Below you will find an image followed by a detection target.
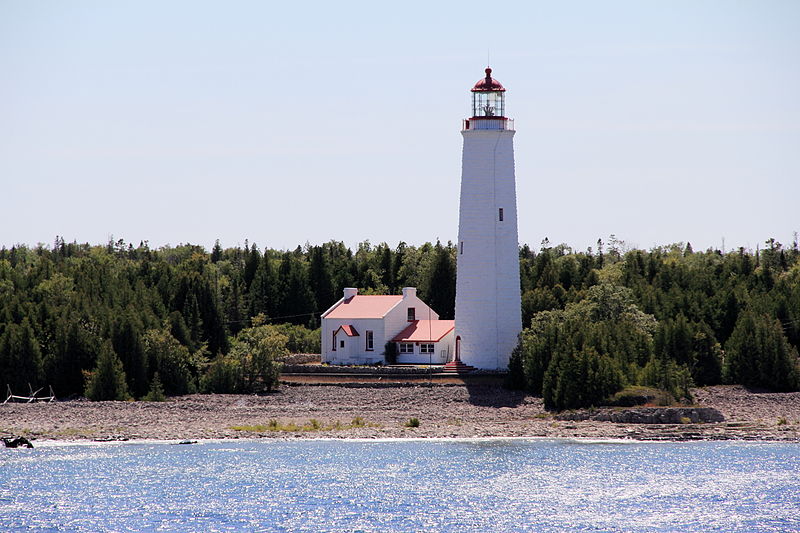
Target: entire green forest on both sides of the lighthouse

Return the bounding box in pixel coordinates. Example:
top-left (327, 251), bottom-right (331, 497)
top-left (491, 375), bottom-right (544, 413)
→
top-left (0, 236), bottom-right (800, 409)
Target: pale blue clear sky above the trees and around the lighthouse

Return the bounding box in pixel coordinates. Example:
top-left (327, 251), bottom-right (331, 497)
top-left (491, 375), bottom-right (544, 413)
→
top-left (0, 0), bottom-right (800, 254)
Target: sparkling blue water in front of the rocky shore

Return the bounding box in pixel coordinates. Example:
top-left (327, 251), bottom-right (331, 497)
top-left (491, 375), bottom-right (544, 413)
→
top-left (0, 440), bottom-right (800, 532)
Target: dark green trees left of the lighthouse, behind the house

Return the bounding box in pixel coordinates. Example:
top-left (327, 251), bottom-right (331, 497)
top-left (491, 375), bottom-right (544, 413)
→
top-left (0, 237), bottom-right (455, 399)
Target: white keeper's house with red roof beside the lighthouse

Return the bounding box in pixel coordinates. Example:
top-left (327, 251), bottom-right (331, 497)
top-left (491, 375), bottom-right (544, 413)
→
top-left (322, 287), bottom-right (455, 365)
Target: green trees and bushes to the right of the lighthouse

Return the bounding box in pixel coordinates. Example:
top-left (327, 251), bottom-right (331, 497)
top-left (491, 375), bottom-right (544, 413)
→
top-left (510, 236), bottom-right (800, 409)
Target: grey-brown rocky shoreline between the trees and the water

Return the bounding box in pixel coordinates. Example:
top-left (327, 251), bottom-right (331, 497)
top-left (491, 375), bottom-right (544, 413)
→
top-left (0, 383), bottom-right (800, 442)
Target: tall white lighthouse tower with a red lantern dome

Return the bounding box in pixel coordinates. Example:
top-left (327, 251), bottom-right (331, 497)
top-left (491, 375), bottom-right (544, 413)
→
top-left (455, 68), bottom-right (522, 370)
